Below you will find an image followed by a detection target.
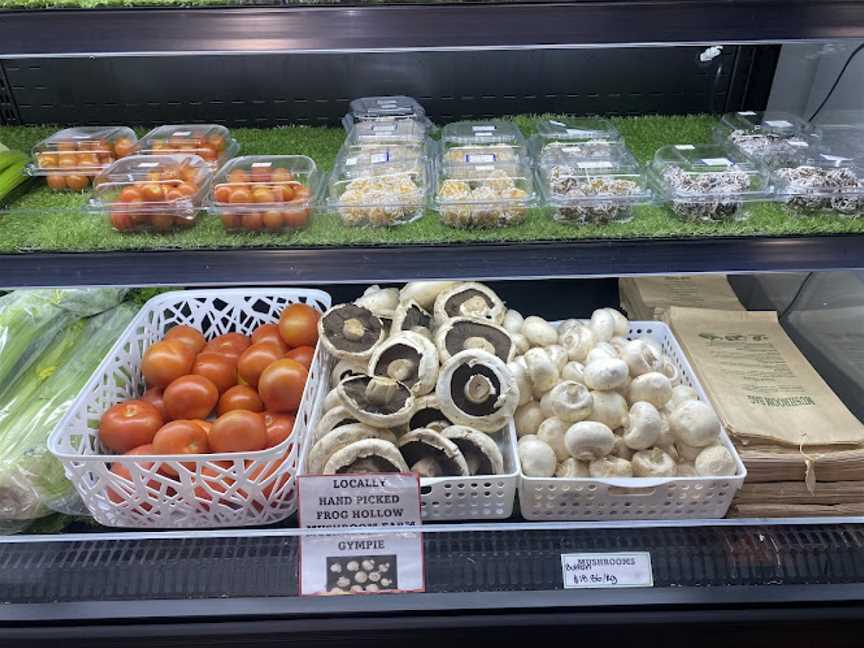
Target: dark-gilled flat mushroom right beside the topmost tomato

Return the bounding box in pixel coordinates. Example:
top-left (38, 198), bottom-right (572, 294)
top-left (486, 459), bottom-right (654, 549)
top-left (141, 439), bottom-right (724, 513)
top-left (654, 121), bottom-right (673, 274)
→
top-left (318, 304), bottom-right (385, 362)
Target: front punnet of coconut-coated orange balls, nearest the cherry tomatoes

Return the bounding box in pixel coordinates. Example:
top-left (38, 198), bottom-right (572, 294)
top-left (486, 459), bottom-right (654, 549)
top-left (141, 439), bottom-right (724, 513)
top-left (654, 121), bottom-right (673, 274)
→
top-left (327, 146), bottom-right (429, 227)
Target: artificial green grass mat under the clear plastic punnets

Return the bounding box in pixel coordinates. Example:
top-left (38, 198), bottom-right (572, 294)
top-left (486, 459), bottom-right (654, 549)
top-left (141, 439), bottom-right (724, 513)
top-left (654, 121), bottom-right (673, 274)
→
top-left (0, 115), bottom-right (864, 253)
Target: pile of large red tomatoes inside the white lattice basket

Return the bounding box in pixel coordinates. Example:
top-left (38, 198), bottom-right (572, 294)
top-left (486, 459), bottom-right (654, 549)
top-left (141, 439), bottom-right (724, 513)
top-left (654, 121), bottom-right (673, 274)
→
top-left (99, 303), bottom-right (320, 496)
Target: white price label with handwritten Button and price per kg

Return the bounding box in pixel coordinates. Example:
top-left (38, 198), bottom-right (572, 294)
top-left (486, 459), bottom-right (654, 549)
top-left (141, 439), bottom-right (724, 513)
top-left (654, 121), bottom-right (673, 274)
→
top-left (561, 551), bottom-right (654, 589)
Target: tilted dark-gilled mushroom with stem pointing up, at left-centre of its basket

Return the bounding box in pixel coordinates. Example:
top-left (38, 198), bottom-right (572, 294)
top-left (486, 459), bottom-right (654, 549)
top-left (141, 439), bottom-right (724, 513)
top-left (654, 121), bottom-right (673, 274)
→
top-left (339, 376), bottom-right (414, 427)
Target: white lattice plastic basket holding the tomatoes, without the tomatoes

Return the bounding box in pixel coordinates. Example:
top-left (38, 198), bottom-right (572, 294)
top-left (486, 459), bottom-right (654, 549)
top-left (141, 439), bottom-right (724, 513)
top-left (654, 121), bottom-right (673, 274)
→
top-left (48, 288), bottom-right (330, 529)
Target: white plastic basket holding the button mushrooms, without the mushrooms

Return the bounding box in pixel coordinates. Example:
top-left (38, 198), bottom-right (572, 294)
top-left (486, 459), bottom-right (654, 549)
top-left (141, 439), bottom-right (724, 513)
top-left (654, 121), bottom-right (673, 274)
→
top-left (519, 322), bottom-right (747, 520)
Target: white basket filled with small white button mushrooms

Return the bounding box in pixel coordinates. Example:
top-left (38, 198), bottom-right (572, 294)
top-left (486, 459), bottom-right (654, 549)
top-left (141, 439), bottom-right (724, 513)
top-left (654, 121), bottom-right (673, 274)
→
top-left (503, 308), bottom-right (747, 520)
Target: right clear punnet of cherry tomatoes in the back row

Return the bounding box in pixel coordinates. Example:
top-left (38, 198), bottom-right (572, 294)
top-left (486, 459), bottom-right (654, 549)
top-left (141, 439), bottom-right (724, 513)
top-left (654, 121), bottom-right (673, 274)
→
top-left (136, 124), bottom-right (240, 171)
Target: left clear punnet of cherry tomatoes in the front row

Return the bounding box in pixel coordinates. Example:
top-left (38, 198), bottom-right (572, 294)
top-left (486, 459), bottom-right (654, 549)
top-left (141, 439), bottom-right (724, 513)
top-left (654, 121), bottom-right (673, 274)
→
top-left (90, 155), bottom-right (212, 232)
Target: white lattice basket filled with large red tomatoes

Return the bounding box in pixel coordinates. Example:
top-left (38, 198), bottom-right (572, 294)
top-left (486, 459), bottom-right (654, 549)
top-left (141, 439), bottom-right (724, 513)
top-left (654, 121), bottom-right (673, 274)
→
top-left (48, 289), bottom-right (330, 529)
